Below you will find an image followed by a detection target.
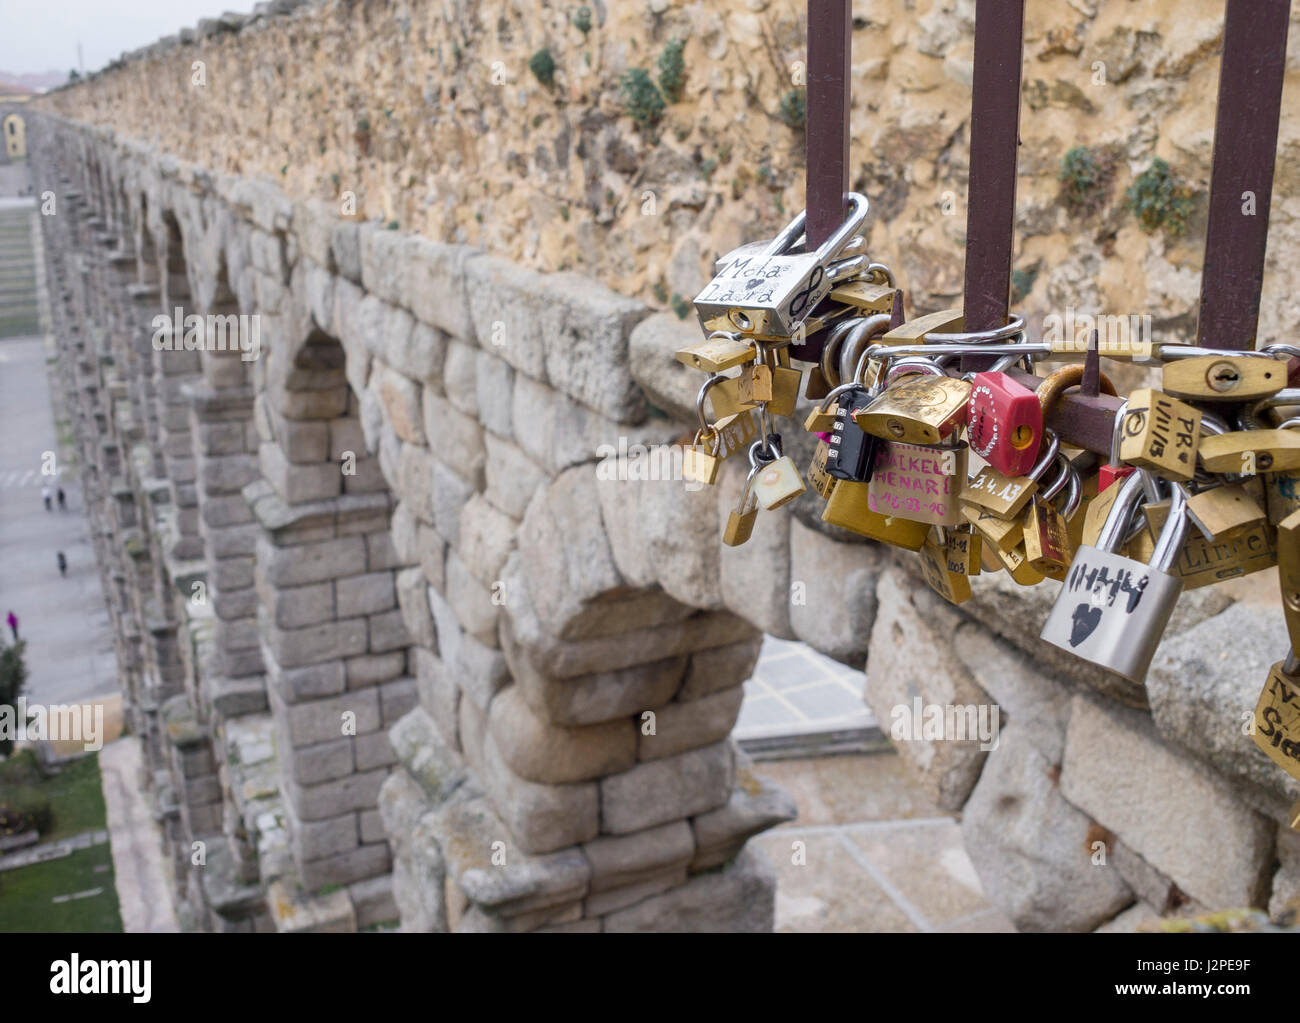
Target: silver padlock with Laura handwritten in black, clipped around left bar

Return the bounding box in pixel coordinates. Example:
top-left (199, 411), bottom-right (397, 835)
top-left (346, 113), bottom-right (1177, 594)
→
top-left (694, 192), bottom-right (867, 338)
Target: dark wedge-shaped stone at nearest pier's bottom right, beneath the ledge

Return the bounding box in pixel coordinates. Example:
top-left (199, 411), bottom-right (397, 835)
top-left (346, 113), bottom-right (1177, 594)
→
top-left (605, 849), bottom-right (776, 933)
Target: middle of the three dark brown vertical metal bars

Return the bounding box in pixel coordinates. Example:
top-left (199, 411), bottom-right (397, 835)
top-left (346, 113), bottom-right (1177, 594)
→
top-left (962, 0), bottom-right (1024, 370)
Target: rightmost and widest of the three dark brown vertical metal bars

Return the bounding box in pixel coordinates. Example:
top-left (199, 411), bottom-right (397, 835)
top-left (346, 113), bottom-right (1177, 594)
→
top-left (1196, 0), bottom-right (1291, 348)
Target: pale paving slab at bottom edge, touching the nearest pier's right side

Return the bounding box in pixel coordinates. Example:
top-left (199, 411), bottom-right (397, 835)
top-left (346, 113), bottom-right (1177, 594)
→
top-left (750, 828), bottom-right (918, 933)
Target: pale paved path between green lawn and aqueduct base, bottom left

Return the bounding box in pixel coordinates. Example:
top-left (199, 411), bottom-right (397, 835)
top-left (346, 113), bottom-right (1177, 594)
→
top-left (99, 736), bottom-right (181, 933)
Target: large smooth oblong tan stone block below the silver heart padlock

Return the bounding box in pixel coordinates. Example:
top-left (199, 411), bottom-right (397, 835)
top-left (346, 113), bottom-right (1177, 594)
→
top-left (1061, 695), bottom-right (1274, 906)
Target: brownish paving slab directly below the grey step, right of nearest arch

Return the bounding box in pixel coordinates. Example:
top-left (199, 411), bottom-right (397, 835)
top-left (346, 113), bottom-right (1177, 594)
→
top-left (755, 753), bottom-right (944, 828)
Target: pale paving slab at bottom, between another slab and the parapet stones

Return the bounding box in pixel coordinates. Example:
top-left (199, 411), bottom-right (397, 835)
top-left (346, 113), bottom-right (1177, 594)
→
top-left (841, 819), bottom-right (992, 927)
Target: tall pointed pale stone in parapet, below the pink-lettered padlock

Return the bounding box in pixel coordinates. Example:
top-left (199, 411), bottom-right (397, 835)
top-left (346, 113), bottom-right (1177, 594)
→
top-left (865, 568), bottom-right (992, 810)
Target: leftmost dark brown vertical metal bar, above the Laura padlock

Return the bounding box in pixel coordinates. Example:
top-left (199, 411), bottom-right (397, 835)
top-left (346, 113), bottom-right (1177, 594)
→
top-left (805, 0), bottom-right (853, 250)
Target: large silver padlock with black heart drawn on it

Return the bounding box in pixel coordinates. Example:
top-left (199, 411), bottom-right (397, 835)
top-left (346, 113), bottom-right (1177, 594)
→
top-left (1041, 471), bottom-right (1187, 685)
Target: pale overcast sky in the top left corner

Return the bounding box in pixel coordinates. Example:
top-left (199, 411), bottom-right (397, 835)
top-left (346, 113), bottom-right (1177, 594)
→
top-left (0, 0), bottom-right (226, 73)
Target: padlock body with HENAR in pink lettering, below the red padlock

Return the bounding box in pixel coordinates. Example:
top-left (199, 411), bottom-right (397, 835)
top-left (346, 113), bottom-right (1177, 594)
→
top-left (868, 441), bottom-right (969, 525)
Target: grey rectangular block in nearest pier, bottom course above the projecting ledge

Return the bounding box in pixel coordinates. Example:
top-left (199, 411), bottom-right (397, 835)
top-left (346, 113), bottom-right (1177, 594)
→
top-left (601, 741), bottom-right (735, 835)
